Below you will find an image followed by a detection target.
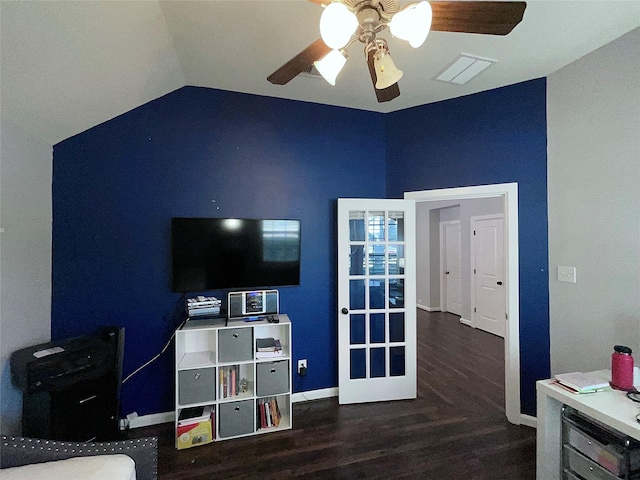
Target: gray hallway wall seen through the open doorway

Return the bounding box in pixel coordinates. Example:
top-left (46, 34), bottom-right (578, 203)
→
top-left (416, 197), bottom-right (504, 320)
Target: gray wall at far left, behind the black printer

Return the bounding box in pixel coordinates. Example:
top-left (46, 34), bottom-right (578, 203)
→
top-left (0, 121), bottom-right (53, 434)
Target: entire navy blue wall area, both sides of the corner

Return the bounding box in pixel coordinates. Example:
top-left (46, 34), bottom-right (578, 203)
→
top-left (51, 80), bottom-right (549, 415)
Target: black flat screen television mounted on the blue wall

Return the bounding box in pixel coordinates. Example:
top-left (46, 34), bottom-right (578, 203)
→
top-left (171, 217), bottom-right (300, 293)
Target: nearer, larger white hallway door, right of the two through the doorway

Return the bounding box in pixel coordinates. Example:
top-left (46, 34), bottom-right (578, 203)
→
top-left (471, 215), bottom-right (507, 338)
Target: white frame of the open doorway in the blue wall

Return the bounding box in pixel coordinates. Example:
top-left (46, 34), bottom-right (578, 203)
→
top-left (404, 182), bottom-right (529, 425)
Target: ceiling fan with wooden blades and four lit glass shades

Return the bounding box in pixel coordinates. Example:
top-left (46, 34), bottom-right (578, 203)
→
top-left (267, 0), bottom-right (527, 102)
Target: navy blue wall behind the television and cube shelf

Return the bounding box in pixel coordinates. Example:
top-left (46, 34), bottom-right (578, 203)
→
top-left (51, 87), bottom-right (386, 415)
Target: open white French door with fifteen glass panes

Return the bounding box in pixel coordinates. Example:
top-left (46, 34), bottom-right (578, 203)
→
top-left (338, 198), bottom-right (417, 404)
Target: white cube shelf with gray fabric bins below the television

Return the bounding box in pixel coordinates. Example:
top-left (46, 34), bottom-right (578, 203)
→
top-left (175, 314), bottom-right (292, 449)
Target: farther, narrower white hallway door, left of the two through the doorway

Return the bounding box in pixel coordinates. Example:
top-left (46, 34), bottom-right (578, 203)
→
top-left (440, 220), bottom-right (462, 315)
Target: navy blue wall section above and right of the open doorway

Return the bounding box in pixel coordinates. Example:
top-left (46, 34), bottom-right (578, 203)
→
top-left (384, 79), bottom-right (550, 415)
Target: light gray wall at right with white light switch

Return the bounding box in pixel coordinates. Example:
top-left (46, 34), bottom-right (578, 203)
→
top-left (547, 29), bottom-right (640, 373)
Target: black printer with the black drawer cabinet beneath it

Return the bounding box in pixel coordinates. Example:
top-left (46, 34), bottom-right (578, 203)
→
top-left (11, 327), bottom-right (124, 441)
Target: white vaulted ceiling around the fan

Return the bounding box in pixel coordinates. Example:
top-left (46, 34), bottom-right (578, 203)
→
top-left (0, 0), bottom-right (640, 145)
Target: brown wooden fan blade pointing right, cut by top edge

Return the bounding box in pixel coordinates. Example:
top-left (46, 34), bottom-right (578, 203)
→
top-left (430, 2), bottom-right (527, 35)
